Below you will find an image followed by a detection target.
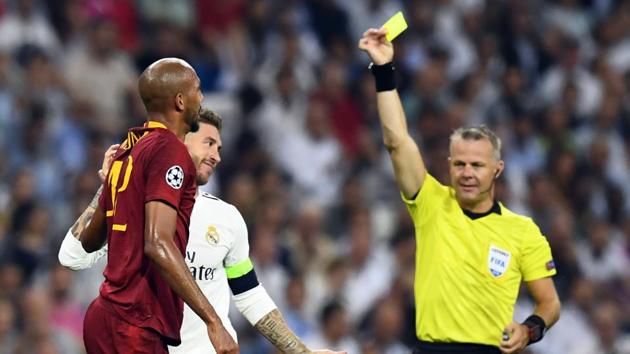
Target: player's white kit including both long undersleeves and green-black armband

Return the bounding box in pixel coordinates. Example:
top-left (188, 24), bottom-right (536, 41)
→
top-left (59, 193), bottom-right (276, 354)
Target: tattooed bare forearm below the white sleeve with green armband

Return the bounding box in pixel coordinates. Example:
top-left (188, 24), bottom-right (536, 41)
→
top-left (255, 309), bottom-right (311, 354)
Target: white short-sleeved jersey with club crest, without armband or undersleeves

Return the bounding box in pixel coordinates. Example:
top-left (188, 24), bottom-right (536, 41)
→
top-left (173, 192), bottom-right (249, 354)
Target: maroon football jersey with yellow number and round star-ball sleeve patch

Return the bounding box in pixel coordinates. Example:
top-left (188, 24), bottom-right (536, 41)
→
top-left (99, 122), bottom-right (197, 345)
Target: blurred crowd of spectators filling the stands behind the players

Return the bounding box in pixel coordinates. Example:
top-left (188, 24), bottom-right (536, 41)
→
top-left (0, 0), bottom-right (630, 354)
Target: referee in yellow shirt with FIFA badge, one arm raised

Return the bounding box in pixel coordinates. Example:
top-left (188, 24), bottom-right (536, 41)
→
top-left (359, 29), bottom-right (560, 354)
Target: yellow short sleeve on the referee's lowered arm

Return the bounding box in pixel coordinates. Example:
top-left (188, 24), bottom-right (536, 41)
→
top-left (521, 224), bottom-right (556, 281)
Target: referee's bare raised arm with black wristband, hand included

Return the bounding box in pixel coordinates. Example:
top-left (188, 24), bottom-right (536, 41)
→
top-left (359, 28), bottom-right (426, 199)
